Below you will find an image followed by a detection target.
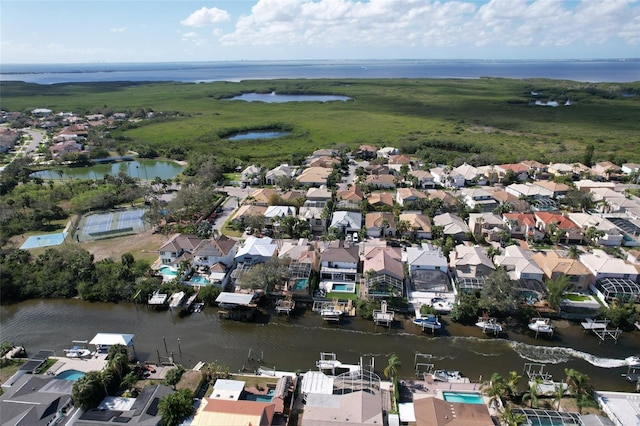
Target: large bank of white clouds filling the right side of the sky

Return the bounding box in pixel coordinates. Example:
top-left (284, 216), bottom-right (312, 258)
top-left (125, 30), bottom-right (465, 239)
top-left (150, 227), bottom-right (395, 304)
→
top-left (218, 0), bottom-right (640, 53)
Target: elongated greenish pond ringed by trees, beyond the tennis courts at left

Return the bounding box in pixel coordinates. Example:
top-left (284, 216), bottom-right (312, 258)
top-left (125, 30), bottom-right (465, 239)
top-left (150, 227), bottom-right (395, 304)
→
top-left (31, 160), bottom-right (184, 180)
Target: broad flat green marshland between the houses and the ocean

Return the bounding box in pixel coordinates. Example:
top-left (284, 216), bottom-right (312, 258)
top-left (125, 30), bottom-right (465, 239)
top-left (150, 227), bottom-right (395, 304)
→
top-left (0, 78), bottom-right (640, 165)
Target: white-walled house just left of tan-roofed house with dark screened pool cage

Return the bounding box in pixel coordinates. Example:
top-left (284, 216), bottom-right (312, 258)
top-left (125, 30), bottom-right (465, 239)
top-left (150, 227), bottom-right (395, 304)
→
top-left (320, 240), bottom-right (360, 283)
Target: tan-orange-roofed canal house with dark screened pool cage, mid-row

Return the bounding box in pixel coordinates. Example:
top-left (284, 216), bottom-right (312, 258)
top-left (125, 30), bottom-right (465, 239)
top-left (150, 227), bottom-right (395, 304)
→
top-left (362, 247), bottom-right (404, 297)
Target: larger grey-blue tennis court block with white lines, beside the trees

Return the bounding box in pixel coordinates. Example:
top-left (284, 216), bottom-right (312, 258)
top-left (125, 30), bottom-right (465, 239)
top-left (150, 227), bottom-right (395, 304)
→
top-left (76, 209), bottom-right (146, 241)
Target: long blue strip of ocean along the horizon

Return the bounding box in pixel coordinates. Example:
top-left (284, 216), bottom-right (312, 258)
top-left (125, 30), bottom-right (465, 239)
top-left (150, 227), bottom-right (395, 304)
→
top-left (0, 58), bottom-right (640, 84)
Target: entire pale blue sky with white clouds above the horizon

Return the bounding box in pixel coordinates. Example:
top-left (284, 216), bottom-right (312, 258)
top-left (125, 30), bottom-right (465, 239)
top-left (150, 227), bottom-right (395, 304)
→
top-left (0, 0), bottom-right (640, 63)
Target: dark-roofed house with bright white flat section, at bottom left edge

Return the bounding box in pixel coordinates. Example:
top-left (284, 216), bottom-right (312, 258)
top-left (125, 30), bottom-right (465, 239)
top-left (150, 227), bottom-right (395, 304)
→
top-left (74, 385), bottom-right (174, 426)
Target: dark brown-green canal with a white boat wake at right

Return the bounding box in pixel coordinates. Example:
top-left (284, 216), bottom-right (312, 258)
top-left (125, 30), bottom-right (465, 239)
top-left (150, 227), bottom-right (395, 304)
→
top-left (0, 300), bottom-right (640, 391)
